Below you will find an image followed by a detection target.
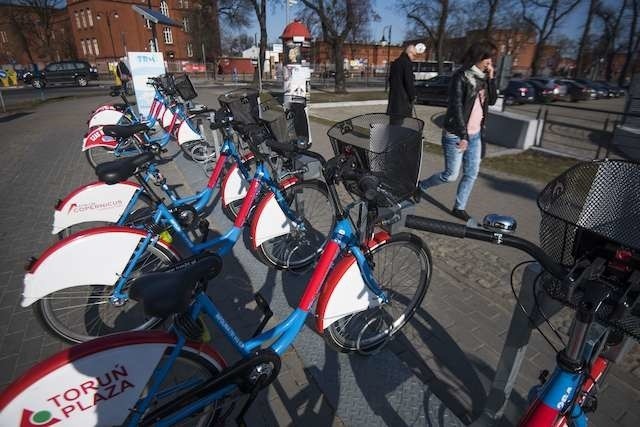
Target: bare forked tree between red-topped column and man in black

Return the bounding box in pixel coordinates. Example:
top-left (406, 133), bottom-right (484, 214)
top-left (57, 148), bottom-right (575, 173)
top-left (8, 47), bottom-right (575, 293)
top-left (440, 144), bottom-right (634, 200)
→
top-left (301, 0), bottom-right (375, 93)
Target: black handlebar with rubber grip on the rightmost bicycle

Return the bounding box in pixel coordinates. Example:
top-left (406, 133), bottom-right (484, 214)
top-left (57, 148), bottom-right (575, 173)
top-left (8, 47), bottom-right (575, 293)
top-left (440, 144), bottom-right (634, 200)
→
top-left (406, 215), bottom-right (567, 280)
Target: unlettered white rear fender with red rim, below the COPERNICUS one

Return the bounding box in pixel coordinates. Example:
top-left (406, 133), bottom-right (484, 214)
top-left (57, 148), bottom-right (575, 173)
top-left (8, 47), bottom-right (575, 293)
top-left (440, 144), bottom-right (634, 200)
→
top-left (20, 227), bottom-right (171, 307)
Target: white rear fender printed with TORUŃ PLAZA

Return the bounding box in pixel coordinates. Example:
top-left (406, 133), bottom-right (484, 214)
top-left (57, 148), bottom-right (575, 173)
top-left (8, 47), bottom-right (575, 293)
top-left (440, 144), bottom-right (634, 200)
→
top-left (0, 331), bottom-right (224, 427)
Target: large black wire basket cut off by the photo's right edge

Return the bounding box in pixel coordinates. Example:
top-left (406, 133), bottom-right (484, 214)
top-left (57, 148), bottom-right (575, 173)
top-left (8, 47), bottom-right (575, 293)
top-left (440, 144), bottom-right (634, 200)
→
top-left (538, 160), bottom-right (640, 266)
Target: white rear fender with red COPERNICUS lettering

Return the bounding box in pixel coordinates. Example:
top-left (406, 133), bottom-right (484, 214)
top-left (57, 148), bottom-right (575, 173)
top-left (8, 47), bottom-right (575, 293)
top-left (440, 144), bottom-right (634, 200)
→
top-left (51, 181), bottom-right (142, 234)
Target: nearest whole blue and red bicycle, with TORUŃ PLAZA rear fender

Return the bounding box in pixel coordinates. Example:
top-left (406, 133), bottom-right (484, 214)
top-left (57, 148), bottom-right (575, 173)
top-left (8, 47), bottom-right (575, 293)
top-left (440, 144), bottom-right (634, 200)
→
top-left (0, 117), bottom-right (431, 426)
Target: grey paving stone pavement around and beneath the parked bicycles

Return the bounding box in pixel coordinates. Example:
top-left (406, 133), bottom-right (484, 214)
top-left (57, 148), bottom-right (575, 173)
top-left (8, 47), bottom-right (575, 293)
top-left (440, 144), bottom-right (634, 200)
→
top-left (0, 91), bottom-right (640, 426)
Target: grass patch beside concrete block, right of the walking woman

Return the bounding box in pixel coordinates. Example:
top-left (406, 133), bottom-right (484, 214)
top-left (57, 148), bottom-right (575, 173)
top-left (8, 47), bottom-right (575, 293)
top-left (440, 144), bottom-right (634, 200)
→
top-left (482, 150), bottom-right (579, 182)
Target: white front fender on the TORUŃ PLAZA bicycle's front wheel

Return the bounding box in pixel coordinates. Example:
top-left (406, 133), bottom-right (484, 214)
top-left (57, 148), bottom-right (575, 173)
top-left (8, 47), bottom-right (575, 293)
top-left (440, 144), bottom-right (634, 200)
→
top-left (316, 232), bottom-right (390, 332)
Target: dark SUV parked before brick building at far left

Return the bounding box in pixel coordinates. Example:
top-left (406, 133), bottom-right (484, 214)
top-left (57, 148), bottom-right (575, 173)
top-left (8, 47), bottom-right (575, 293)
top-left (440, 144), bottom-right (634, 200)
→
top-left (24, 61), bottom-right (98, 89)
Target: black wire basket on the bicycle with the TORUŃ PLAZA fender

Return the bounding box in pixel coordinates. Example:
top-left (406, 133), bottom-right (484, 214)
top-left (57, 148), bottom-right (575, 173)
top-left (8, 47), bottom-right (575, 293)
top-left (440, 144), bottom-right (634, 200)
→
top-left (327, 113), bottom-right (424, 205)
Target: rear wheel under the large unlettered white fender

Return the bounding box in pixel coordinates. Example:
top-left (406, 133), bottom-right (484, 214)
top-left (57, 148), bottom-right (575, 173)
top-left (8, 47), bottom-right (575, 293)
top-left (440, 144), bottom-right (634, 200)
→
top-left (34, 244), bottom-right (177, 342)
